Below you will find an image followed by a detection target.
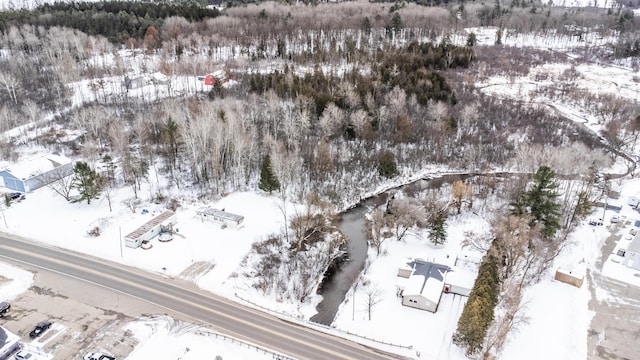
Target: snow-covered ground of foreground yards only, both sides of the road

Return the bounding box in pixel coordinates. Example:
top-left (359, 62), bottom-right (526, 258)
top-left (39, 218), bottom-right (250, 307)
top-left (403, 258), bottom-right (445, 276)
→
top-left (0, 169), bottom-right (638, 360)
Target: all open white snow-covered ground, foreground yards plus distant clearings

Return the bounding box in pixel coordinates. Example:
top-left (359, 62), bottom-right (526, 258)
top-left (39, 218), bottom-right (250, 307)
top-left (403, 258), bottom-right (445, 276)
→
top-left (0, 0), bottom-right (640, 360)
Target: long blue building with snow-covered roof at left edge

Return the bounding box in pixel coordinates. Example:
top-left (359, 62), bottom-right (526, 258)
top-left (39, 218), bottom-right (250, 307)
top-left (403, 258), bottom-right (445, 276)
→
top-left (0, 154), bottom-right (73, 192)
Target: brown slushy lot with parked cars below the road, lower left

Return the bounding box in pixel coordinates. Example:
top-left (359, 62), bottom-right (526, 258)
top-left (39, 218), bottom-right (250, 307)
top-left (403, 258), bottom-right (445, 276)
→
top-left (0, 271), bottom-right (166, 360)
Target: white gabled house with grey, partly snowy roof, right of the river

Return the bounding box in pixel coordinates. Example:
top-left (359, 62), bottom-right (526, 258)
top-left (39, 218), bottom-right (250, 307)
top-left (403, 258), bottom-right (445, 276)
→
top-left (402, 260), bottom-right (449, 312)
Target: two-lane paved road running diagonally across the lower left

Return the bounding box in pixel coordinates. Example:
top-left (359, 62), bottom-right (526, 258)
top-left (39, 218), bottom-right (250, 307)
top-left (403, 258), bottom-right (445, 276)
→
top-left (0, 236), bottom-right (399, 360)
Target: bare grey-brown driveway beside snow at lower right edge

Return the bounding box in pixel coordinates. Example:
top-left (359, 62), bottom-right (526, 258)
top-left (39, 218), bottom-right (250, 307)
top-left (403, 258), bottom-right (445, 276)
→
top-left (587, 224), bottom-right (640, 360)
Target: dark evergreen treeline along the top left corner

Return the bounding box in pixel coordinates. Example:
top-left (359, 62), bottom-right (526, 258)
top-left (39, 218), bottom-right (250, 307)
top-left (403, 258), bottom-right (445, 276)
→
top-left (0, 1), bottom-right (220, 42)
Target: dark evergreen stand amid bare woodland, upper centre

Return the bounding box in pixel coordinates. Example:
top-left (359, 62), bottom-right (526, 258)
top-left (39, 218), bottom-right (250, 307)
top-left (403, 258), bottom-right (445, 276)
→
top-left (247, 41), bottom-right (475, 116)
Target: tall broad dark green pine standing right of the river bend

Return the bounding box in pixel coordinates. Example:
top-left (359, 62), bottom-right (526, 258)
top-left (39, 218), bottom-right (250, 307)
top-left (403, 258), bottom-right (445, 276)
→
top-left (512, 166), bottom-right (560, 238)
